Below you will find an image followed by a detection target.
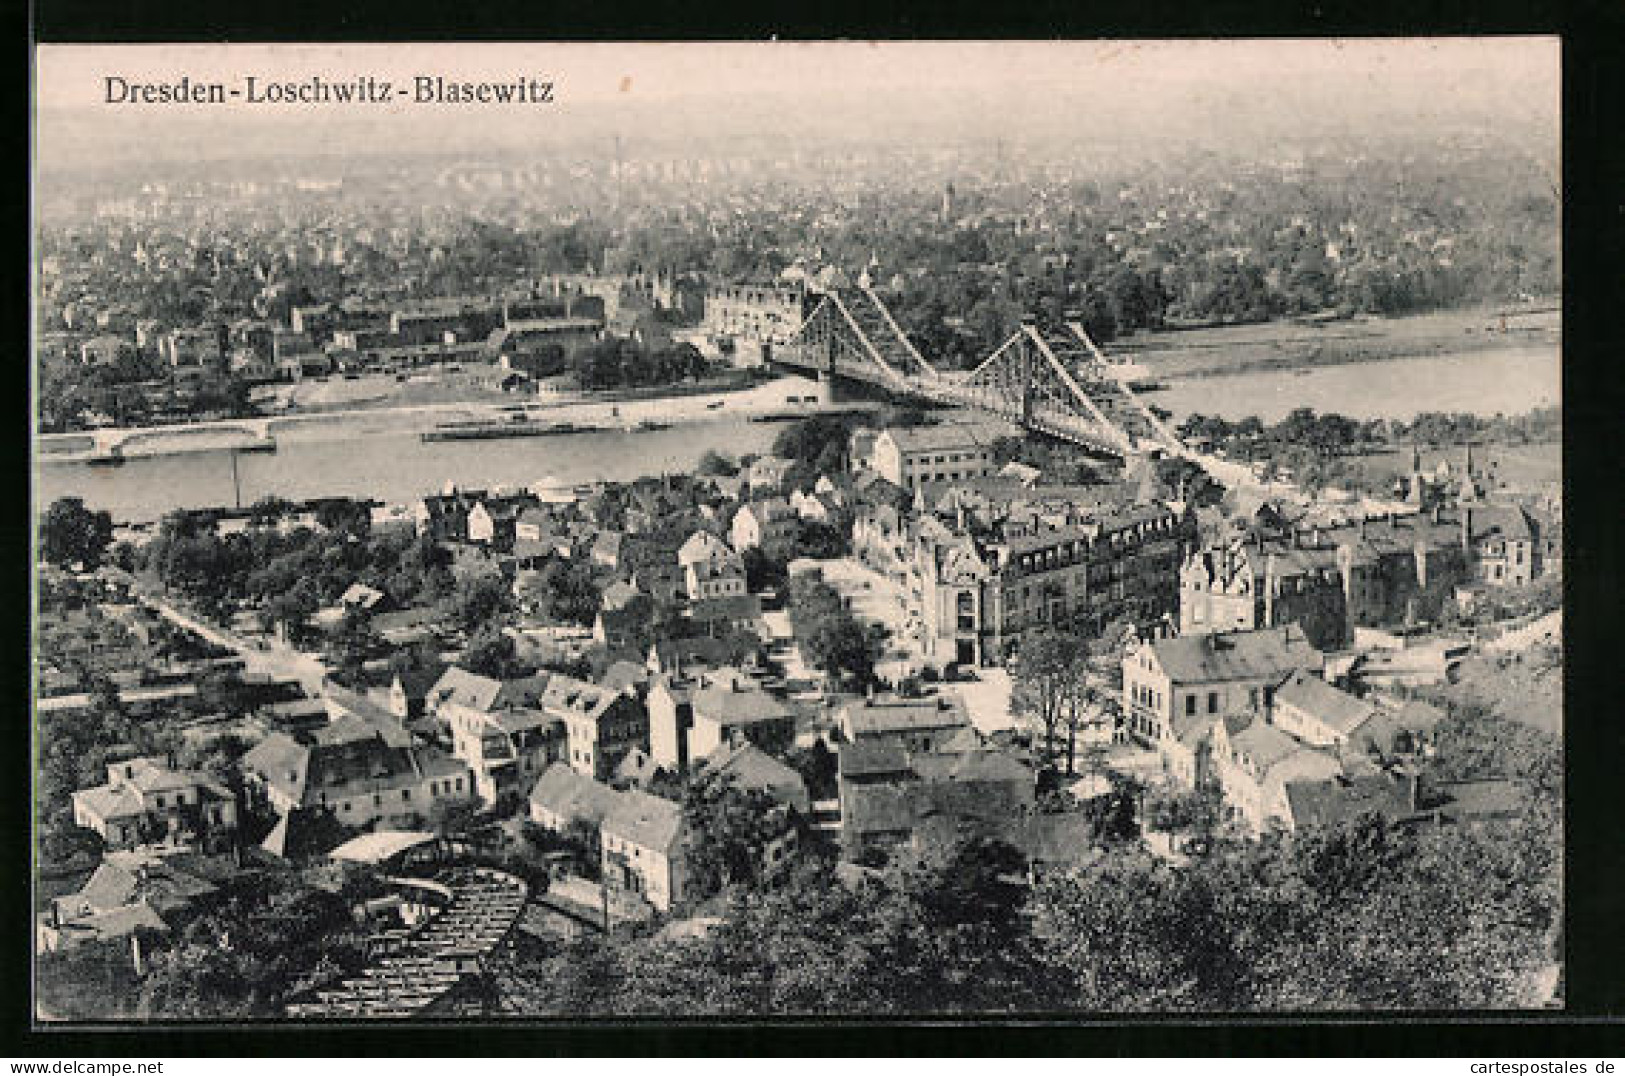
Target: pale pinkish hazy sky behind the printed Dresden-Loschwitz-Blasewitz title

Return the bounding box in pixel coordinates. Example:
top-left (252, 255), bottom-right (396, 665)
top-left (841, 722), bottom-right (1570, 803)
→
top-left (36, 39), bottom-right (1558, 166)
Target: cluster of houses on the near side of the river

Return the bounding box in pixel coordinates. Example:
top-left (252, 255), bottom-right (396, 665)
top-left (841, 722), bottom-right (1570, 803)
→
top-left (41, 406), bottom-right (1552, 948)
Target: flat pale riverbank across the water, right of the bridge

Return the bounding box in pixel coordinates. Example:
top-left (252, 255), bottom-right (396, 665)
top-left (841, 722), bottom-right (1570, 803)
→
top-left (1105, 304), bottom-right (1562, 382)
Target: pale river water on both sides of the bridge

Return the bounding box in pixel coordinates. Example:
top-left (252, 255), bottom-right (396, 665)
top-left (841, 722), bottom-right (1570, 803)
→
top-left (34, 348), bottom-right (1562, 522)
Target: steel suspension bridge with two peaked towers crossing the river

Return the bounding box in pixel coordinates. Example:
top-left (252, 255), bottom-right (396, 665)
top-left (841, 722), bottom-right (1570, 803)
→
top-left (772, 281), bottom-right (1190, 458)
